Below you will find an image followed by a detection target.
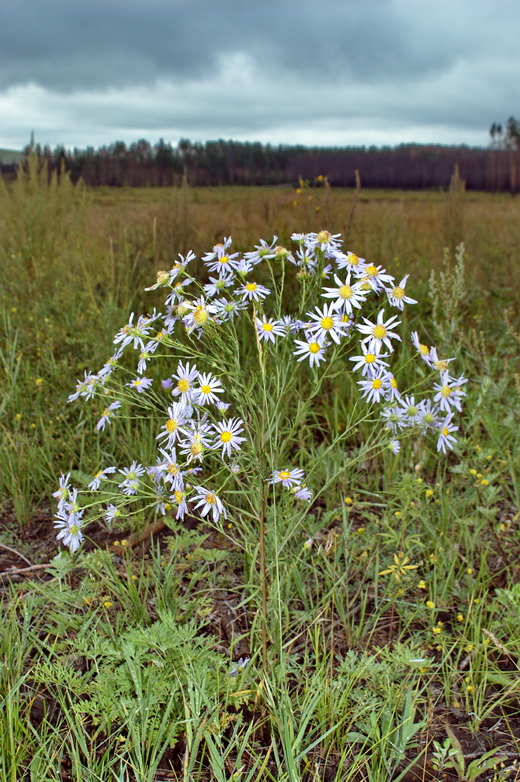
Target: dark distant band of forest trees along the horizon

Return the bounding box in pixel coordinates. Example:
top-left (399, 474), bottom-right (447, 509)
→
top-left (2, 139), bottom-right (520, 193)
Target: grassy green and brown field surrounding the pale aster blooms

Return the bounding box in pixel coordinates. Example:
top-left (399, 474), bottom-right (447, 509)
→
top-left (0, 160), bottom-right (520, 782)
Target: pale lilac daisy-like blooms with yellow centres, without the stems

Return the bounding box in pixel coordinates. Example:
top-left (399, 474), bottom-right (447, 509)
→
top-left (55, 230), bottom-right (466, 550)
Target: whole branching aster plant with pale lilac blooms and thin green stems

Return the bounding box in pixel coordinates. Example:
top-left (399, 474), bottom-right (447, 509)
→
top-left (55, 230), bottom-right (466, 660)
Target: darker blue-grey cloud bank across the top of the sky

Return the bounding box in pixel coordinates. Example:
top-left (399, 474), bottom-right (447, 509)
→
top-left (0, 0), bottom-right (484, 91)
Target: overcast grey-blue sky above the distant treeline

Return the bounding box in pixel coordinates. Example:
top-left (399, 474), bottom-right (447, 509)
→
top-left (0, 0), bottom-right (520, 149)
